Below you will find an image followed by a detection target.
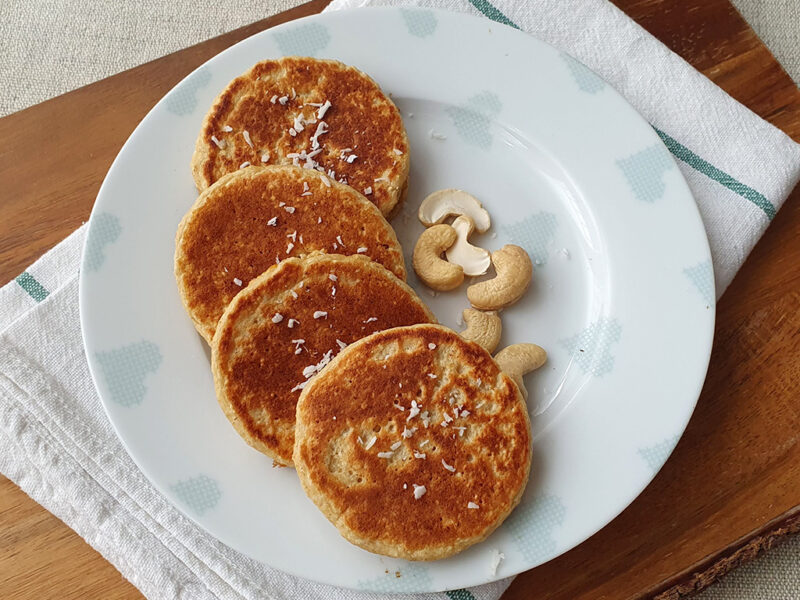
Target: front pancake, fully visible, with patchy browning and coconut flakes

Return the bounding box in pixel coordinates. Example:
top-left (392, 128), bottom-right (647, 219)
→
top-left (294, 325), bottom-right (531, 560)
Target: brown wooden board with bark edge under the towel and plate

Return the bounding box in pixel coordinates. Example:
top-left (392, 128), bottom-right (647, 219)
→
top-left (0, 0), bottom-right (800, 600)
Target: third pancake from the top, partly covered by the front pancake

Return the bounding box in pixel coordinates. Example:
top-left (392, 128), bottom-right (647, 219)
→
top-left (211, 254), bottom-right (435, 465)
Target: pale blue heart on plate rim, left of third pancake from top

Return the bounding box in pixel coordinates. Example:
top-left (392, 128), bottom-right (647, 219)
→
top-left (95, 341), bottom-right (162, 407)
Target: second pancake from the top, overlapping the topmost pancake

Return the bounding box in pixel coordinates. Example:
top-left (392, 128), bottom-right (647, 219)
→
top-left (175, 167), bottom-right (405, 342)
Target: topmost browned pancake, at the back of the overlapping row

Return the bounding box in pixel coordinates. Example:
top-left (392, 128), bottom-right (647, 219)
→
top-left (192, 56), bottom-right (409, 215)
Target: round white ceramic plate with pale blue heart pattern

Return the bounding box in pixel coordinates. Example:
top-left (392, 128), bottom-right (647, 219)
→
top-left (80, 9), bottom-right (714, 592)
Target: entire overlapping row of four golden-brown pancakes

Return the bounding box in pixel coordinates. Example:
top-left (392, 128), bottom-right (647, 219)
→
top-left (175, 57), bottom-right (531, 560)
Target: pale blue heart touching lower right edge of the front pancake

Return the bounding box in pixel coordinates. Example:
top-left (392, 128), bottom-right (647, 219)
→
top-left (506, 494), bottom-right (567, 563)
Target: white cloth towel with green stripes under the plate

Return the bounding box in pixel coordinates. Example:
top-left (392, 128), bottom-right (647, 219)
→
top-left (0, 0), bottom-right (800, 600)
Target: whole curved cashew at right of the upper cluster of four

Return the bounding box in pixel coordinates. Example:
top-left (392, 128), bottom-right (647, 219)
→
top-left (467, 244), bottom-right (533, 310)
